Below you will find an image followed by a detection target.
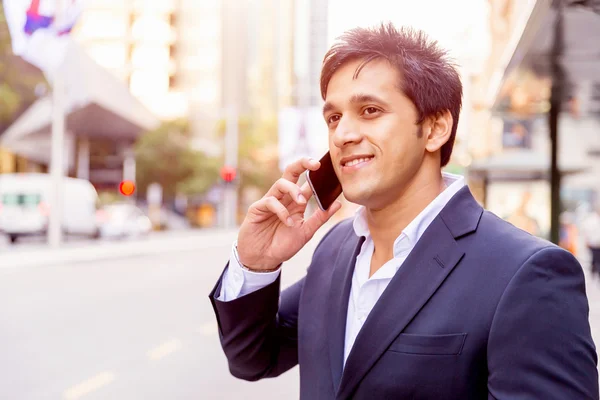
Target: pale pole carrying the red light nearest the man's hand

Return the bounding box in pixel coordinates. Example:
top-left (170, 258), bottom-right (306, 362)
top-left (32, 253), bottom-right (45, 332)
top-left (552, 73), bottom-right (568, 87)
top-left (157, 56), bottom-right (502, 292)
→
top-left (223, 106), bottom-right (239, 228)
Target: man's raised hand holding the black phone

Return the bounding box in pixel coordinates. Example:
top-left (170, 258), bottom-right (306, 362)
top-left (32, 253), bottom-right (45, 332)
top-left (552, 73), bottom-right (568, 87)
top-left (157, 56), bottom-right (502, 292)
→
top-left (237, 158), bottom-right (342, 271)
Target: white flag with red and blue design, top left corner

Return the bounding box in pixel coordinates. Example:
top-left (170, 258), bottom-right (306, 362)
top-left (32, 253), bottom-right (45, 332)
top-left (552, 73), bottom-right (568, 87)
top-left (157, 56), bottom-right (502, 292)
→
top-left (3, 0), bottom-right (84, 76)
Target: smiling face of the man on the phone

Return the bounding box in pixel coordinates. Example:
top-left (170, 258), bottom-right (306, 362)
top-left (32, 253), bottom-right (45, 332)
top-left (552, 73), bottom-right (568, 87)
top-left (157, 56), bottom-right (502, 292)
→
top-left (323, 60), bottom-right (426, 209)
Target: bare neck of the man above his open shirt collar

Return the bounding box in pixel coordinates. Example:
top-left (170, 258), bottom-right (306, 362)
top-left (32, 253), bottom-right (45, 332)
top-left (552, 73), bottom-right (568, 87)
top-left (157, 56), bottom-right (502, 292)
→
top-left (366, 165), bottom-right (445, 262)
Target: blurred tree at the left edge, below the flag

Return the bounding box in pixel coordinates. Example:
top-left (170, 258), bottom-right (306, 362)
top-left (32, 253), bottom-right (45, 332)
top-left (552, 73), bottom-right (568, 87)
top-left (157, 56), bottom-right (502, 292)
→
top-left (0, 7), bottom-right (46, 134)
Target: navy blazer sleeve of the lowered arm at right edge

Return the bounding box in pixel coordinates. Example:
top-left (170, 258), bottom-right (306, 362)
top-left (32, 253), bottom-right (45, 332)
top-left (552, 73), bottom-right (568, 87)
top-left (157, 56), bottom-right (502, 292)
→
top-left (487, 246), bottom-right (598, 400)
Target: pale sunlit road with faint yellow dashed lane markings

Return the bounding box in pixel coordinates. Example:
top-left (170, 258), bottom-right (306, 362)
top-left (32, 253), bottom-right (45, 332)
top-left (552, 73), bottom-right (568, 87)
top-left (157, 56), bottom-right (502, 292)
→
top-left (0, 228), bottom-right (600, 400)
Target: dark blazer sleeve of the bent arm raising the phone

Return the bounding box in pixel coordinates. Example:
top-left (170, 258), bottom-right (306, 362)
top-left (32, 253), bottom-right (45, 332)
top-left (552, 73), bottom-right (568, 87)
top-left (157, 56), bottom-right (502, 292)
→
top-left (209, 275), bottom-right (305, 381)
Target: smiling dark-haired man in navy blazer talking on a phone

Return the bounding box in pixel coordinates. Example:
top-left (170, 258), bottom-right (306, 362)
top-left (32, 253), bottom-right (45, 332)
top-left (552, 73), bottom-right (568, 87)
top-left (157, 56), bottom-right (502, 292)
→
top-left (210, 25), bottom-right (598, 400)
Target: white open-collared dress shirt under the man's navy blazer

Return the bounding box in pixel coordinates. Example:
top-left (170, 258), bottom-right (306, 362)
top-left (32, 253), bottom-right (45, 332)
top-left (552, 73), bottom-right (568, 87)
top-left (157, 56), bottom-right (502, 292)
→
top-left (218, 173), bottom-right (465, 364)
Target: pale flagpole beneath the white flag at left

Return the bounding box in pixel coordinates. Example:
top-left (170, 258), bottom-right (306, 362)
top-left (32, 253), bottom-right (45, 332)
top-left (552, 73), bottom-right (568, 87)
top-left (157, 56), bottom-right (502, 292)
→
top-left (48, 0), bottom-right (65, 247)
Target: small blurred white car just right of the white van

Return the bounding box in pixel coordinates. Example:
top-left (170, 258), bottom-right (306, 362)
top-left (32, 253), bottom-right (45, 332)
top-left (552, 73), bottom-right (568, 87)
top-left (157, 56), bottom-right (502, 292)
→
top-left (97, 203), bottom-right (152, 238)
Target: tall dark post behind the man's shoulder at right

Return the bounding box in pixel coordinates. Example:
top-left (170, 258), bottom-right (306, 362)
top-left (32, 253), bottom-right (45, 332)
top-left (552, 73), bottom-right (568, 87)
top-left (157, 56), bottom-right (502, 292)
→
top-left (548, 1), bottom-right (565, 244)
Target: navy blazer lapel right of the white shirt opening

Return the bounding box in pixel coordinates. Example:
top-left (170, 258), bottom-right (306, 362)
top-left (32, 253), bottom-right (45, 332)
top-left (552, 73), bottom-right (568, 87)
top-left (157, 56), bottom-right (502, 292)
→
top-left (336, 188), bottom-right (483, 399)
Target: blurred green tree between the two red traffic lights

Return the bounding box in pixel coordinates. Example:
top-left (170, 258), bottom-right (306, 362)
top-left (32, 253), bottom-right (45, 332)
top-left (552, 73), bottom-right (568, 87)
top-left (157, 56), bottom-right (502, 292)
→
top-left (135, 121), bottom-right (219, 200)
